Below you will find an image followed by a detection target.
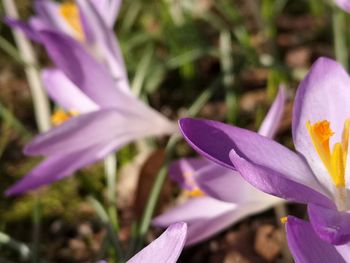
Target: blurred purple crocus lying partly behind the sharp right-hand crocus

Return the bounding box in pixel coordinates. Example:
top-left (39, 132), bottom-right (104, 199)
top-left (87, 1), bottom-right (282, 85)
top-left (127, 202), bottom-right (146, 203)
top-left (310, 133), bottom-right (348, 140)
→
top-left (153, 86), bottom-right (285, 245)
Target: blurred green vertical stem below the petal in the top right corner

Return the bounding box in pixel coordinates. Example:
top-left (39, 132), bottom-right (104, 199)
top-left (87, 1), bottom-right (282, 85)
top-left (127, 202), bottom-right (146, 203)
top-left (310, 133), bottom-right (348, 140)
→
top-left (332, 7), bottom-right (349, 70)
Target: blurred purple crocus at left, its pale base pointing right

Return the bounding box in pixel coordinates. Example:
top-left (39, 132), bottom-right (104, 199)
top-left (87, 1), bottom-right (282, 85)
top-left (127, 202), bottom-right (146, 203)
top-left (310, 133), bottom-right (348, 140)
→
top-left (6, 30), bottom-right (177, 195)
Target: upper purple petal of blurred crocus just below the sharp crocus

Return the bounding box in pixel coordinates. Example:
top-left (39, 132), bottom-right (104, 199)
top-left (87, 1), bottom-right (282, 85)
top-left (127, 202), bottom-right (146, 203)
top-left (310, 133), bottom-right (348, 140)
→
top-left (195, 166), bottom-right (282, 204)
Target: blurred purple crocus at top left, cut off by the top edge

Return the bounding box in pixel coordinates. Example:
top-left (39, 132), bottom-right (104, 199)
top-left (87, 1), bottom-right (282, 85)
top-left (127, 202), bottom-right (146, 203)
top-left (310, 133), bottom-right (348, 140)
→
top-left (5, 0), bottom-right (130, 92)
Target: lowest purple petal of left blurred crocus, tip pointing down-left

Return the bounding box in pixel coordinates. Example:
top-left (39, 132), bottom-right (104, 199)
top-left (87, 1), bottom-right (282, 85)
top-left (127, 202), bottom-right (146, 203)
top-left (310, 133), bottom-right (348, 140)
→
top-left (5, 141), bottom-right (118, 196)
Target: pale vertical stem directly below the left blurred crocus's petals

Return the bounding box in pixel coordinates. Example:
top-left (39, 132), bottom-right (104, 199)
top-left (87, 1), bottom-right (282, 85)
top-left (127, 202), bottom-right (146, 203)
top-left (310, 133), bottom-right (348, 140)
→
top-left (105, 154), bottom-right (119, 232)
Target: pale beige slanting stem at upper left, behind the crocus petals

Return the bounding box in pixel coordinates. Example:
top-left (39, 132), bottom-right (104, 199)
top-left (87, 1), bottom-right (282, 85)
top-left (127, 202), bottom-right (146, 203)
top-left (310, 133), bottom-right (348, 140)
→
top-left (3, 0), bottom-right (51, 132)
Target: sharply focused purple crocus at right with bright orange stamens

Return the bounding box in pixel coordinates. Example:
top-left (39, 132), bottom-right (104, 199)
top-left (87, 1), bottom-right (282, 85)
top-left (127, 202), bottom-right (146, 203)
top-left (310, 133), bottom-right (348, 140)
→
top-left (180, 58), bottom-right (350, 245)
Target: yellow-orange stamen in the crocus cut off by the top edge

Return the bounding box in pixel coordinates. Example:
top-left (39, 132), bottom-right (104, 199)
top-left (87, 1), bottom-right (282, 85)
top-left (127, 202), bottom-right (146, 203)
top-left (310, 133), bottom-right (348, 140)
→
top-left (59, 2), bottom-right (84, 40)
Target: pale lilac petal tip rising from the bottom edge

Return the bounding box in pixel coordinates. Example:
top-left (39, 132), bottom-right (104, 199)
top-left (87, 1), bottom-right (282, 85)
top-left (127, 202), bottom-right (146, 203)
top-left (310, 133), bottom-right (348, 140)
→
top-left (127, 223), bottom-right (187, 263)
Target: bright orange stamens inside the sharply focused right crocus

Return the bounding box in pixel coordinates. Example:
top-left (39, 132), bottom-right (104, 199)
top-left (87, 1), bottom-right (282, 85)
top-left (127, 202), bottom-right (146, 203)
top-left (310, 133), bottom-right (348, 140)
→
top-left (306, 119), bottom-right (350, 210)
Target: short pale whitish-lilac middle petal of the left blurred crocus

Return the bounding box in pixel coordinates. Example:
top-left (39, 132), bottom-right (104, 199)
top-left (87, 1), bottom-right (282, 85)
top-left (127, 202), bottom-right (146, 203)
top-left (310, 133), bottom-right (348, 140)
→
top-left (41, 68), bottom-right (99, 114)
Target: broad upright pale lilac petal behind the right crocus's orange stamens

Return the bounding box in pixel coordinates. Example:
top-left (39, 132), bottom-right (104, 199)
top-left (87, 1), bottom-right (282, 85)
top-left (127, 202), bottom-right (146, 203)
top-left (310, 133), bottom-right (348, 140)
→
top-left (292, 58), bottom-right (350, 193)
